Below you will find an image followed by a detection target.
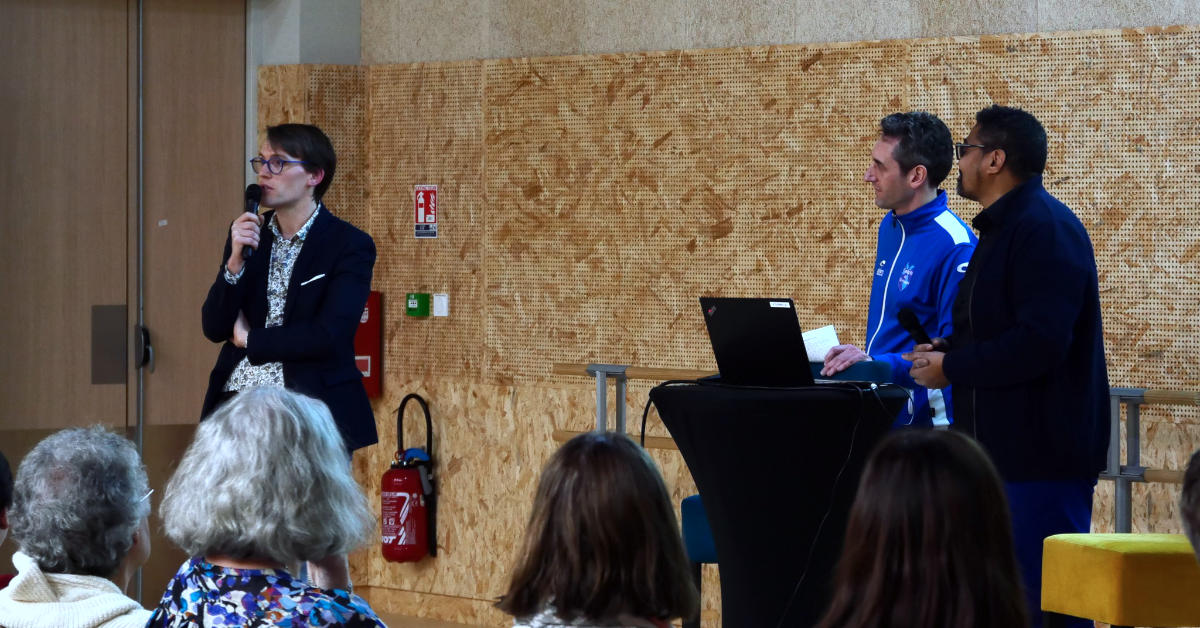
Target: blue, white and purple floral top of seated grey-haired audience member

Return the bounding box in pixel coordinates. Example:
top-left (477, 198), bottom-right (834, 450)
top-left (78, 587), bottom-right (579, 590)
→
top-left (146, 557), bottom-right (386, 628)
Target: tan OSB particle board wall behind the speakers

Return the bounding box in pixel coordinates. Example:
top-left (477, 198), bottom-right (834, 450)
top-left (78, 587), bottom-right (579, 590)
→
top-left (259, 23), bottom-right (1200, 624)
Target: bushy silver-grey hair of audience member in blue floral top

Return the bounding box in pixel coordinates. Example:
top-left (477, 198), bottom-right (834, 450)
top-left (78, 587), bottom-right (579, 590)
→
top-left (161, 387), bottom-right (374, 564)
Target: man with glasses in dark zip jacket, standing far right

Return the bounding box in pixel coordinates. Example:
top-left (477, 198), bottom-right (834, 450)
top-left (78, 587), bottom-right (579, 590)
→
top-left (905, 106), bottom-right (1110, 627)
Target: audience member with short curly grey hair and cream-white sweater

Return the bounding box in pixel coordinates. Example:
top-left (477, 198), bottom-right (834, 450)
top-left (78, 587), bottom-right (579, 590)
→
top-left (0, 426), bottom-right (150, 628)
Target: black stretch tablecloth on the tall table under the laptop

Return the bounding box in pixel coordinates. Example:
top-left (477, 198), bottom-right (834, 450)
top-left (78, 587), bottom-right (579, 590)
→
top-left (650, 383), bottom-right (907, 628)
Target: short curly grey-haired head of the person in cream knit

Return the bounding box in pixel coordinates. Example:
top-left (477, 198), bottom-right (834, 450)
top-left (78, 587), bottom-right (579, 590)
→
top-left (10, 425), bottom-right (150, 578)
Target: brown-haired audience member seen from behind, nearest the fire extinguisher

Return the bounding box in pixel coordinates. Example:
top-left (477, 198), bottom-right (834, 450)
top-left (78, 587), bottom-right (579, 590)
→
top-left (497, 432), bottom-right (700, 628)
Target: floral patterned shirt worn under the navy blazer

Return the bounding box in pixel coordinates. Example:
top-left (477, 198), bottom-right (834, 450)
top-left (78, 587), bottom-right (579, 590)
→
top-left (224, 204), bottom-right (320, 391)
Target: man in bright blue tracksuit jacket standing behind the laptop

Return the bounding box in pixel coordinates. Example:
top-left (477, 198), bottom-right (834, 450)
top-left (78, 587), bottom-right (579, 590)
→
top-left (821, 112), bottom-right (976, 426)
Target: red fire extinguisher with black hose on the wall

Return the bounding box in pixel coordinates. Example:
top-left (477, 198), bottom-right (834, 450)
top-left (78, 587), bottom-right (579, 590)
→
top-left (382, 393), bottom-right (438, 562)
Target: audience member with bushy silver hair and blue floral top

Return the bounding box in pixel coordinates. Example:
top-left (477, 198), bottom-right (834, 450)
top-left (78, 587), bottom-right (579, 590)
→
top-left (148, 387), bottom-right (384, 627)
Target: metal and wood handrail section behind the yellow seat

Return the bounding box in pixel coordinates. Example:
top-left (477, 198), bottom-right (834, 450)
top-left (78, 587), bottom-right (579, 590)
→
top-left (1100, 388), bottom-right (1200, 532)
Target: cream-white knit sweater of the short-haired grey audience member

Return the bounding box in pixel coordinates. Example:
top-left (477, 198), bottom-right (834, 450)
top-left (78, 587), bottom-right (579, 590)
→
top-left (0, 551), bottom-right (150, 628)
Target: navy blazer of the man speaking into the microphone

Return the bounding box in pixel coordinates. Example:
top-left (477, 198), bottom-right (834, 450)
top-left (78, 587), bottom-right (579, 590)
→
top-left (200, 205), bottom-right (379, 451)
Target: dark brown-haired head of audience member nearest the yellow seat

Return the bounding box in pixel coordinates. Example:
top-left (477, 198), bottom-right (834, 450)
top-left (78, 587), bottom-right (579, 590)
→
top-left (820, 430), bottom-right (1028, 628)
